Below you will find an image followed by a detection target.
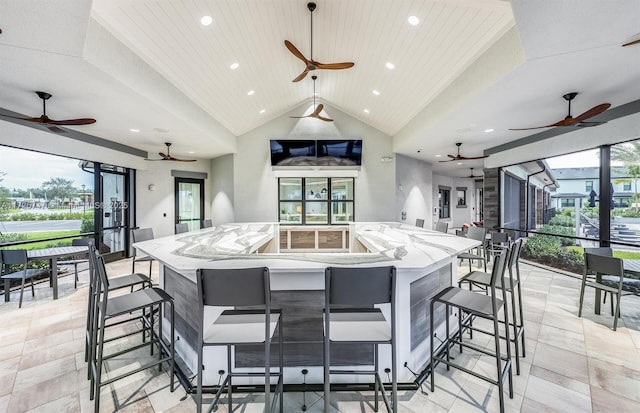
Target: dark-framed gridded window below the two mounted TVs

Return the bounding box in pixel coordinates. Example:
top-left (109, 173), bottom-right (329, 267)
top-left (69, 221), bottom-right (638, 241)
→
top-left (278, 178), bottom-right (354, 225)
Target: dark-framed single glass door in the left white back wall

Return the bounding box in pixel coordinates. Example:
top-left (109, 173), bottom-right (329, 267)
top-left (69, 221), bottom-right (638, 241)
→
top-left (175, 178), bottom-right (204, 231)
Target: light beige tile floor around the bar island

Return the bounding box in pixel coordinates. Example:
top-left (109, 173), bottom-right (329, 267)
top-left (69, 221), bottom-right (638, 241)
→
top-left (0, 260), bottom-right (640, 413)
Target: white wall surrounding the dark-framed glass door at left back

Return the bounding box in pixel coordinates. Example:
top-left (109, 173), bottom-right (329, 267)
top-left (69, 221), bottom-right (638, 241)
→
top-left (136, 160), bottom-right (211, 237)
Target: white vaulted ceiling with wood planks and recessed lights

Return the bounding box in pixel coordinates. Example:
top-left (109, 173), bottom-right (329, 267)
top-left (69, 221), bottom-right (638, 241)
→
top-left (0, 0), bottom-right (640, 175)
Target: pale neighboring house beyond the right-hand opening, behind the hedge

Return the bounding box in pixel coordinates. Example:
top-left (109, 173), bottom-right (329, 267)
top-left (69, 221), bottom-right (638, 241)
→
top-left (551, 167), bottom-right (637, 210)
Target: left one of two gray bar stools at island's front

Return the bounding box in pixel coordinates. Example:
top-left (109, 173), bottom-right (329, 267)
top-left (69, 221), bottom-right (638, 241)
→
top-left (196, 267), bottom-right (284, 413)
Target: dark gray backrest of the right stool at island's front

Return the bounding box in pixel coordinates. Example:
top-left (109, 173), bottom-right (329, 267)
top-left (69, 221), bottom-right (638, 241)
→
top-left (325, 266), bottom-right (396, 306)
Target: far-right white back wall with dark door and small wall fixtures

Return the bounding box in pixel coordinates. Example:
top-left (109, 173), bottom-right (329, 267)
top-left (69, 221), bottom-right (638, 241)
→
top-left (432, 174), bottom-right (476, 230)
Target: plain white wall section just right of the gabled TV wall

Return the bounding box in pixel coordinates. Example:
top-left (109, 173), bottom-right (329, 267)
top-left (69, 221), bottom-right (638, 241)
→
top-left (395, 155), bottom-right (438, 228)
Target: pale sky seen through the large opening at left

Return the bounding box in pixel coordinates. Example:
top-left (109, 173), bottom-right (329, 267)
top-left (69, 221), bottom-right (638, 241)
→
top-left (0, 146), bottom-right (93, 189)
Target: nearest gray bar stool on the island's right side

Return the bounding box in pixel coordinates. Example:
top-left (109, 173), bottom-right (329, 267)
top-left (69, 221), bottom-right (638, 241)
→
top-left (429, 251), bottom-right (513, 412)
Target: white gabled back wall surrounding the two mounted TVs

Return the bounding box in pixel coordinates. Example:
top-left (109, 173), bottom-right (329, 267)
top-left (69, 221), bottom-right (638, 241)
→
top-left (233, 104), bottom-right (396, 222)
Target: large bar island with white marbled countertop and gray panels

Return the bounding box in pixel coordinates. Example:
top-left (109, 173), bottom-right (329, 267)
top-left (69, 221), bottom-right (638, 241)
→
top-left (134, 222), bottom-right (478, 385)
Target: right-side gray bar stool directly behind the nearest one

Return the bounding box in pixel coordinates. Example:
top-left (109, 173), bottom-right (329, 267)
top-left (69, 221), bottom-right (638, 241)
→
top-left (458, 238), bottom-right (527, 374)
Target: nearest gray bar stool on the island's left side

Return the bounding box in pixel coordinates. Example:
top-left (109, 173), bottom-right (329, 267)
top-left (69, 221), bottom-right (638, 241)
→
top-left (89, 246), bottom-right (175, 412)
